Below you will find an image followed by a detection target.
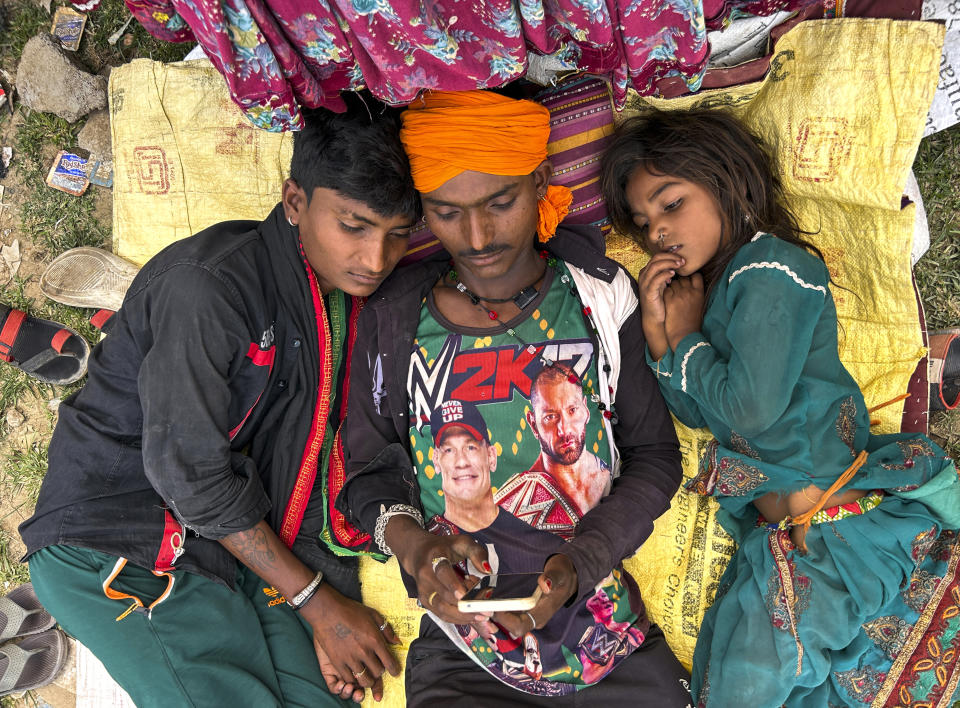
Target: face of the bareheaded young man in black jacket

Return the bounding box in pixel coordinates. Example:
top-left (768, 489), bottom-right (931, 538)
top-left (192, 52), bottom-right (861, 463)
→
top-left (283, 179), bottom-right (415, 297)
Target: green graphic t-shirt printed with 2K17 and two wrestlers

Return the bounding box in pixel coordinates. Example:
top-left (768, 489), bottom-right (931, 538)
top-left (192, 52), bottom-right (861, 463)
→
top-left (407, 262), bottom-right (649, 695)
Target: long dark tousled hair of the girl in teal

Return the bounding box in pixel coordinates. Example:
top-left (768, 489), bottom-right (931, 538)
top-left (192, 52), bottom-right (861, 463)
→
top-left (600, 109), bottom-right (823, 288)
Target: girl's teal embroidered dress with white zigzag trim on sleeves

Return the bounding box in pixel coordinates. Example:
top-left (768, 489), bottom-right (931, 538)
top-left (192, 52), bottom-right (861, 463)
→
top-left (647, 234), bottom-right (960, 708)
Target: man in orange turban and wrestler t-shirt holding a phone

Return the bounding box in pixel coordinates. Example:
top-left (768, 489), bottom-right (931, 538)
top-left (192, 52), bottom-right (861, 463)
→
top-left (337, 91), bottom-right (690, 708)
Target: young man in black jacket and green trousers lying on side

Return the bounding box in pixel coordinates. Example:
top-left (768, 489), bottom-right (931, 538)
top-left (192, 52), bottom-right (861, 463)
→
top-left (20, 95), bottom-right (419, 708)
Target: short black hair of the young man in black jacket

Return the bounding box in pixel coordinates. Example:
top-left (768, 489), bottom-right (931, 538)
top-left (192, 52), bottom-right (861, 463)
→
top-left (290, 92), bottom-right (420, 219)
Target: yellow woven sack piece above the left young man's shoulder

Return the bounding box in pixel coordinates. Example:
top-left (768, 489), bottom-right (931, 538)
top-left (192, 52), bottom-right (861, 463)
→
top-left (109, 59), bottom-right (293, 265)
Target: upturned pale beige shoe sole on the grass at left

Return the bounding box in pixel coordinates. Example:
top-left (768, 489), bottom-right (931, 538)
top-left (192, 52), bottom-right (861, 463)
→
top-left (40, 246), bottom-right (139, 311)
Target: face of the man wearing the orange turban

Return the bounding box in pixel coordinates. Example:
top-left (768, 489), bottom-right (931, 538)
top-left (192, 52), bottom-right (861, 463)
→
top-left (421, 162), bottom-right (551, 280)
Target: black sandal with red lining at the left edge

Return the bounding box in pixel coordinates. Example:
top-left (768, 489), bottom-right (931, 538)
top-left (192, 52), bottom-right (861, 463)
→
top-left (0, 305), bottom-right (90, 386)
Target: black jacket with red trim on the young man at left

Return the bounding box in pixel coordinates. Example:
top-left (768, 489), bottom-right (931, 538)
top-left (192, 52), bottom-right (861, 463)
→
top-left (20, 205), bottom-right (350, 585)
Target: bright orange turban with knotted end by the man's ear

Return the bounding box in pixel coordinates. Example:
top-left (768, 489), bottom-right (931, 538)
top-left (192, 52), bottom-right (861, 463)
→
top-left (400, 91), bottom-right (573, 241)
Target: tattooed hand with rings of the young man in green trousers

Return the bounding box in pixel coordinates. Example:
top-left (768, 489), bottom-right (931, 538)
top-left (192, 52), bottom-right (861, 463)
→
top-left (300, 585), bottom-right (400, 703)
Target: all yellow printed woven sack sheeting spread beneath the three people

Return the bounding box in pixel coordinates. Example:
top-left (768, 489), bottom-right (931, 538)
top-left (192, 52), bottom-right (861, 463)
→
top-left (110, 19), bottom-right (943, 706)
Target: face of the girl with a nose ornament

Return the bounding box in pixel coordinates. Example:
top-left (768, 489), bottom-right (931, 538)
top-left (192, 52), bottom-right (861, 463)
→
top-left (626, 167), bottom-right (723, 275)
